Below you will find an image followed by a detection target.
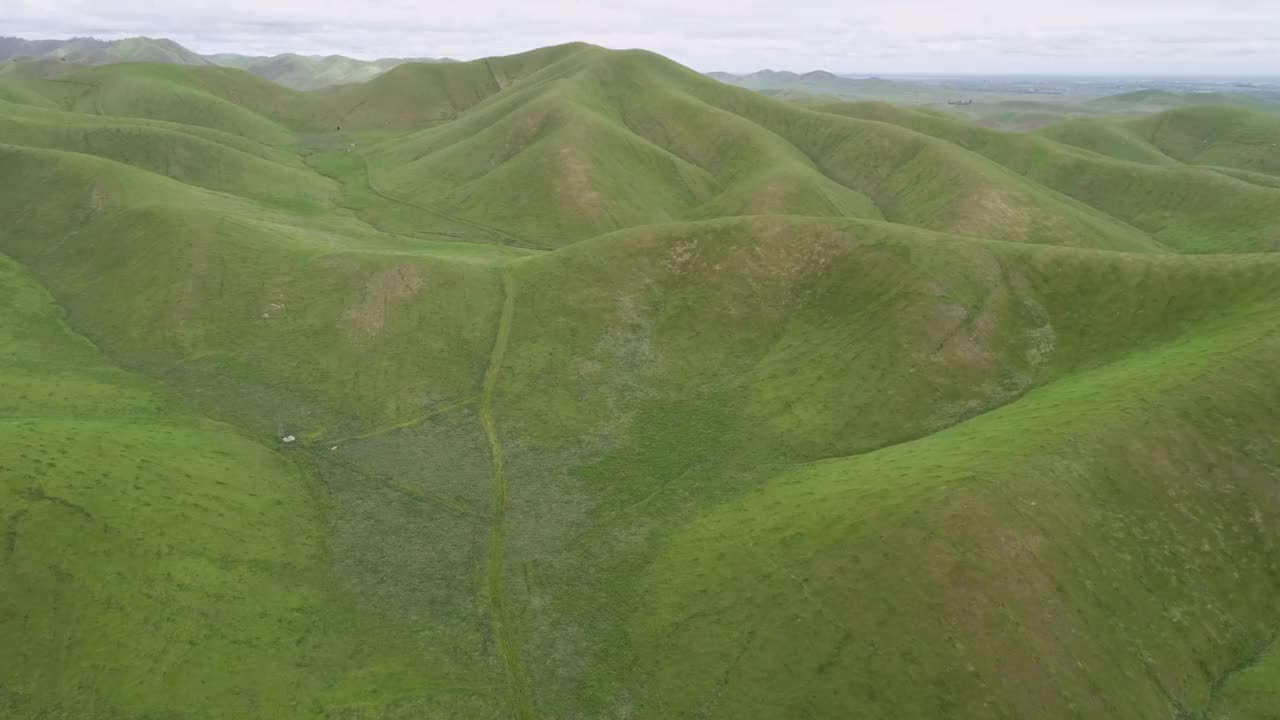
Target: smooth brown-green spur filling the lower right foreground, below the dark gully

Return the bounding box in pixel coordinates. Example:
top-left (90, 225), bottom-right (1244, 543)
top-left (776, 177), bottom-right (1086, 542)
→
top-left (614, 230), bottom-right (1277, 717)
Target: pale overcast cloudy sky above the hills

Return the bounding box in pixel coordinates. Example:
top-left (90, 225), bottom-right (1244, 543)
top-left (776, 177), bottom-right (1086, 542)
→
top-left (0, 0), bottom-right (1280, 76)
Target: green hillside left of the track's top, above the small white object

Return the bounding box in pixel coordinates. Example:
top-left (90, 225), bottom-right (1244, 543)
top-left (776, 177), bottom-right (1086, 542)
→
top-left (0, 139), bottom-right (506, 428)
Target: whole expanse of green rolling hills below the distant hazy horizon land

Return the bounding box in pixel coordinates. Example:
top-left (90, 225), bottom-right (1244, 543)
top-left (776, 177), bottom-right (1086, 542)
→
top-left (0, 44), bottom-right (1280, 720)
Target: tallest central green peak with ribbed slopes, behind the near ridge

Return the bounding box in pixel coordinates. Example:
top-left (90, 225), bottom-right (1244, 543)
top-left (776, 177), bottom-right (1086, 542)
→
top-left (355, 46), bottom-right (1157, 250)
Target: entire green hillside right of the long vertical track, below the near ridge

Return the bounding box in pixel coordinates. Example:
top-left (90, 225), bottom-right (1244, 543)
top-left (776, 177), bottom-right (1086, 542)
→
top-left (478, 219), bottom-right (1277, 717)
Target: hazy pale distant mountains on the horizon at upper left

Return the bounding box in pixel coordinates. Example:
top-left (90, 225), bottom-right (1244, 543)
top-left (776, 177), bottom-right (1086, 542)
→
top-left (0, 37), bottom-right (454, 90)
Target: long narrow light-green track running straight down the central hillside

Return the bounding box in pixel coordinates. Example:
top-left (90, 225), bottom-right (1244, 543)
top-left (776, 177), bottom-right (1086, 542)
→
top-left (480, 266), bottom-right (535, 720)
